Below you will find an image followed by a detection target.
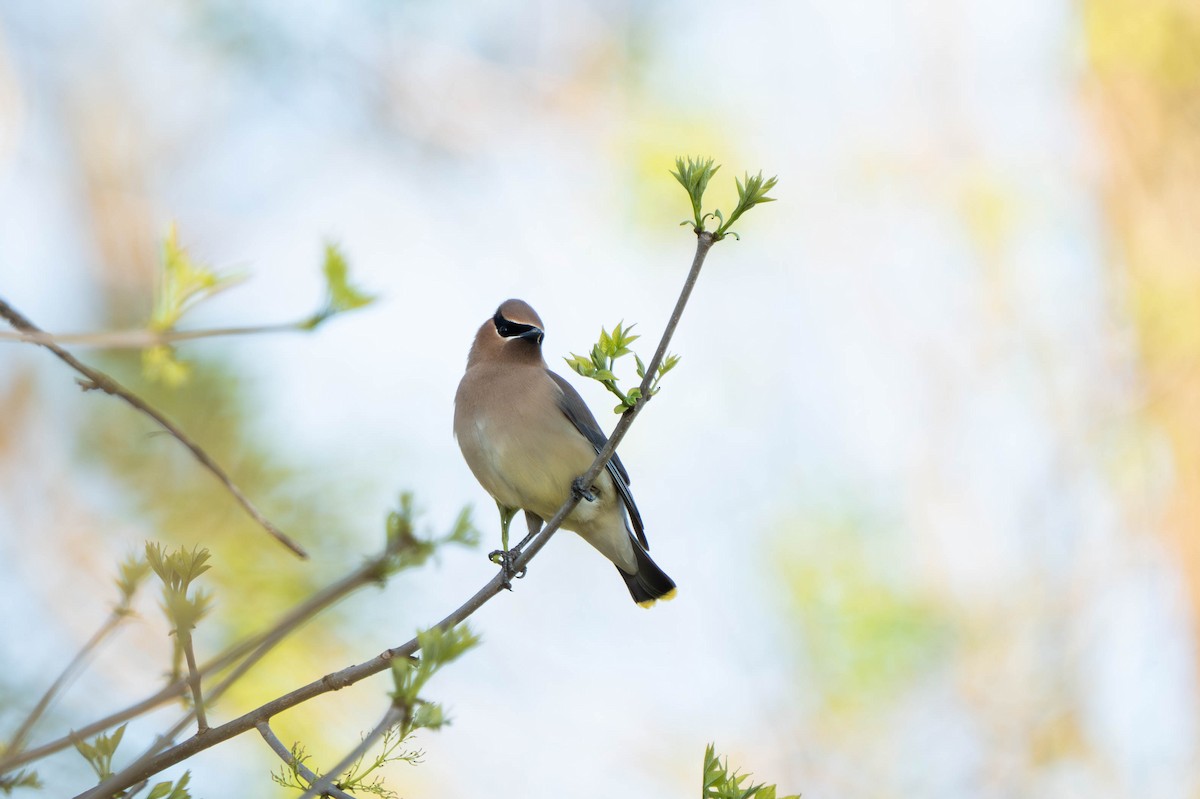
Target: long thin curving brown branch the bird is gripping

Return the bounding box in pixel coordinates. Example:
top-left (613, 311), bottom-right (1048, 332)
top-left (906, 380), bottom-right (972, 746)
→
top-left (76, 226), bottom-right (714, 799)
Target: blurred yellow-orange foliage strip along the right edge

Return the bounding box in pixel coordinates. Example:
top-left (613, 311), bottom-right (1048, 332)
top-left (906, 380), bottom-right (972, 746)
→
top-left (1084, 0), bottom-right (1200, 652)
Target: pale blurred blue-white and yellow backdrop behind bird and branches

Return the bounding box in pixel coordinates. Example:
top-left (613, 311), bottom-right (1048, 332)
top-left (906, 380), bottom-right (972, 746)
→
top-left (0, 0), bottom-right (1200, 798)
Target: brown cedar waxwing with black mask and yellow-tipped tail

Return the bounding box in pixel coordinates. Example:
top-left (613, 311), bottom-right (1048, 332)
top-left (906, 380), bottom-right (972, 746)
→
top-left (454, 300), bottom-right (676, 607)
